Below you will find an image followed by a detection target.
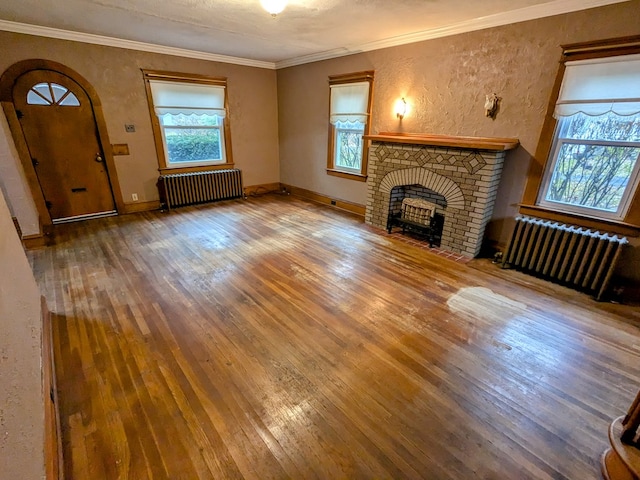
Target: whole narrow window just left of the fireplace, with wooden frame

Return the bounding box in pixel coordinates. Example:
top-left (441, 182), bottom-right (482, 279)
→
top-left (327, 72), bottom-right (373, 181)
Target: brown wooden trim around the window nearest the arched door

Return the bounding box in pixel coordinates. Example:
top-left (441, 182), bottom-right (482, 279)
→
top-left (142, 69), bottom-right (234, 174)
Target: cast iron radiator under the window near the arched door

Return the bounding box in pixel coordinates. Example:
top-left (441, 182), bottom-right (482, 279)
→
top-left (158, 168), bottom-right (243, 209)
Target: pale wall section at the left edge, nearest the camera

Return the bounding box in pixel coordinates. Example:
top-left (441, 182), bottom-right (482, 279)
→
top-left (0, 187), bottom-right (44, 479)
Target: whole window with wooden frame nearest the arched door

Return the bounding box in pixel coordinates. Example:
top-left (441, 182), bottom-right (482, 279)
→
top-left (145, 72), bottom-right (231, 170)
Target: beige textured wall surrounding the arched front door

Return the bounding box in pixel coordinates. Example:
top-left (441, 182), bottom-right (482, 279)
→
top-left (0, 32), bottom-right (279, 216)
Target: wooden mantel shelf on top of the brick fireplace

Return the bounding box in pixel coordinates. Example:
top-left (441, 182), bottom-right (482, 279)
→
top-left (364, 132), bottom-right (520, 151)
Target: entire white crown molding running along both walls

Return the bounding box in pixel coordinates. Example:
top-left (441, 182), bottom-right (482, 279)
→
top-left (0, 0), bottom-right (629, 70)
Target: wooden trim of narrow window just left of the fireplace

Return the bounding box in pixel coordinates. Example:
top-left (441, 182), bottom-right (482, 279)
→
top-left (327, 70), bottom-right (375, 182)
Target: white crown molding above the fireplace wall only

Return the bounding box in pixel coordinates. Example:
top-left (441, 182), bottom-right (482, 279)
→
top-left (275, 0), bottom-right (629, 70)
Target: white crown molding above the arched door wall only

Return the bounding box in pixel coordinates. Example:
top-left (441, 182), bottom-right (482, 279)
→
top-left (0, 20), bottom-right (276, 70)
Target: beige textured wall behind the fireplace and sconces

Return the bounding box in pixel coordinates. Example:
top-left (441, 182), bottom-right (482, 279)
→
top-left (278, 0), bottom-right (640, 270)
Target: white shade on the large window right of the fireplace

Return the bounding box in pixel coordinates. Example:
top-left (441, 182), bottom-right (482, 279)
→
top-left (554, 55), bottom-right (640, 118)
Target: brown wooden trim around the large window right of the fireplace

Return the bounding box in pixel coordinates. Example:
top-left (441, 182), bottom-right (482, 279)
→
top-left (519, 35), bottom-right (640, 236)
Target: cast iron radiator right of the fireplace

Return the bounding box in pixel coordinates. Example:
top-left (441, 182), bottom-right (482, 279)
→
top-left (502, 216), bottom-right (629, 300)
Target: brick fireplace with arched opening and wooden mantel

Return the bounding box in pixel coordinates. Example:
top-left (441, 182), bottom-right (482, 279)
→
top-left (365, 133), bottom-right (519, 257)
